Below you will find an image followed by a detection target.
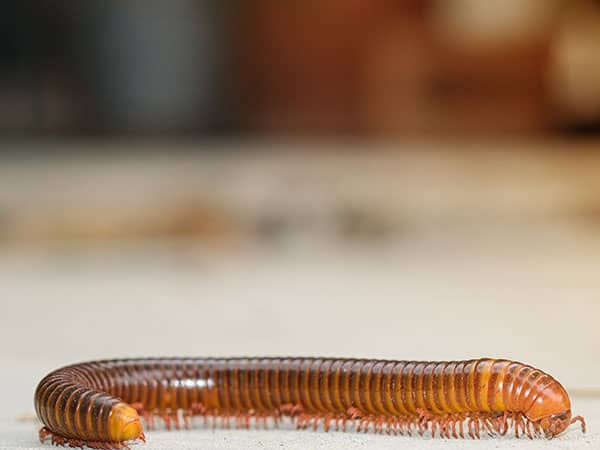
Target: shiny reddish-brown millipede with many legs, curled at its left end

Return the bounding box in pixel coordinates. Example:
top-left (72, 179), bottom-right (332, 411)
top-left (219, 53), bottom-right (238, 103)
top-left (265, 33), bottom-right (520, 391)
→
top-left (34, 357), bottom-right (585, 449)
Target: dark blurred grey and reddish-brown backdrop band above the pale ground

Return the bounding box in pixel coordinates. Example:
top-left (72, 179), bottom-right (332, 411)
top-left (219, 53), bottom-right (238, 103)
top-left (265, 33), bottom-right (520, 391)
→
top-left (0, 0), bottom-right (600, 138)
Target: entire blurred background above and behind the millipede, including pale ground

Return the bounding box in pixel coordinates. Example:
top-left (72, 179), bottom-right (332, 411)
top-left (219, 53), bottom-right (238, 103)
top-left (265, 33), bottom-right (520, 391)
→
top-left (0, 0), bottom-right (600, 442)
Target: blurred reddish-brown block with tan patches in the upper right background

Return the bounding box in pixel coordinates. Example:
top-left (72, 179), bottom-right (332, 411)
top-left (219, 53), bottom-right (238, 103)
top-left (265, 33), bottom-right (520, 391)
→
top-left (239, 0), bottom-right (600, 137)
